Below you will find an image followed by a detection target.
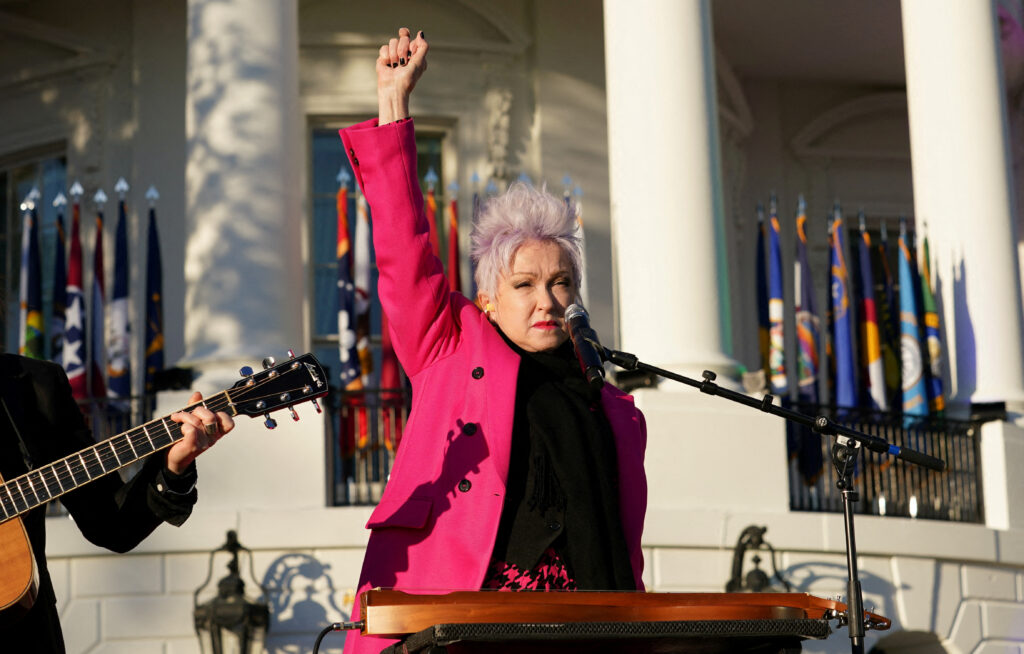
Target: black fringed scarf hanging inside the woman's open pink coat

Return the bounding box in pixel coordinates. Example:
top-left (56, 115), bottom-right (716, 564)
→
top-left (493, 331), bottom-right (636, 591)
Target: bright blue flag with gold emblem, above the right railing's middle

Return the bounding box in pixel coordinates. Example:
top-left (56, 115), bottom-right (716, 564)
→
top-left (830, 203), bottom-right (857, 407)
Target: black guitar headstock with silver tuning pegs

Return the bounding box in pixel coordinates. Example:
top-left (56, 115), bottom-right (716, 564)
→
top-left (227, 353), bottom-right (328, 429)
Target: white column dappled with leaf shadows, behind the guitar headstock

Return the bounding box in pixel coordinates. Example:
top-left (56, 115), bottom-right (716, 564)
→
top-left (182, 0), bottom-right (305, 390)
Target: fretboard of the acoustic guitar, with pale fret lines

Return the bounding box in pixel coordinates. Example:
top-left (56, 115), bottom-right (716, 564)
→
top-left (0, 391), bottom-right (234, 522)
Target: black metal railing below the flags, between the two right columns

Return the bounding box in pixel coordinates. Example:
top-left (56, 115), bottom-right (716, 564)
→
top-left (787, 406), bottom-right (985, 523)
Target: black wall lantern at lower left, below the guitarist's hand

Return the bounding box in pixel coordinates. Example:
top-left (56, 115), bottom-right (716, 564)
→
top-left (193, 531), bottom-right (270, 654)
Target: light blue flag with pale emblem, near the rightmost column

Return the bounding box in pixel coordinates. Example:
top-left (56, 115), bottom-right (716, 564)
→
top-left (899, 218), bottom-right (928, 416)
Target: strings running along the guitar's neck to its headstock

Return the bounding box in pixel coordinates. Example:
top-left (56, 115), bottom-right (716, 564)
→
top-left (0, 368), bottom-right (319, 519)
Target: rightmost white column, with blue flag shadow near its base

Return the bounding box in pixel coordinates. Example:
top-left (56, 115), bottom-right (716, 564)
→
top-left (902, 0), bottom-right (1024, 405)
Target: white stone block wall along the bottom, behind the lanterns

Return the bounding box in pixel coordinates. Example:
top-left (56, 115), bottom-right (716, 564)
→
top-left (50, 519), bottom-right (1024, 654)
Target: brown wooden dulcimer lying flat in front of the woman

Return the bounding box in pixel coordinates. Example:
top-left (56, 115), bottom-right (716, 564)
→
top-left (360, 588), bottom-right (890, 654)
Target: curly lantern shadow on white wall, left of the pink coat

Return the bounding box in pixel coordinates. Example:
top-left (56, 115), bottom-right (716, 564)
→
top-left (262, 553), bottom-right (349, 654)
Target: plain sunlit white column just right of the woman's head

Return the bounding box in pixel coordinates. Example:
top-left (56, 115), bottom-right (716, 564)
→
top-left (604, 0), bottom-right (735, 380)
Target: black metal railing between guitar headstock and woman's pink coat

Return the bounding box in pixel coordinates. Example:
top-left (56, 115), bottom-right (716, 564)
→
top-left (325, 388), bottom-right (412, 506)
